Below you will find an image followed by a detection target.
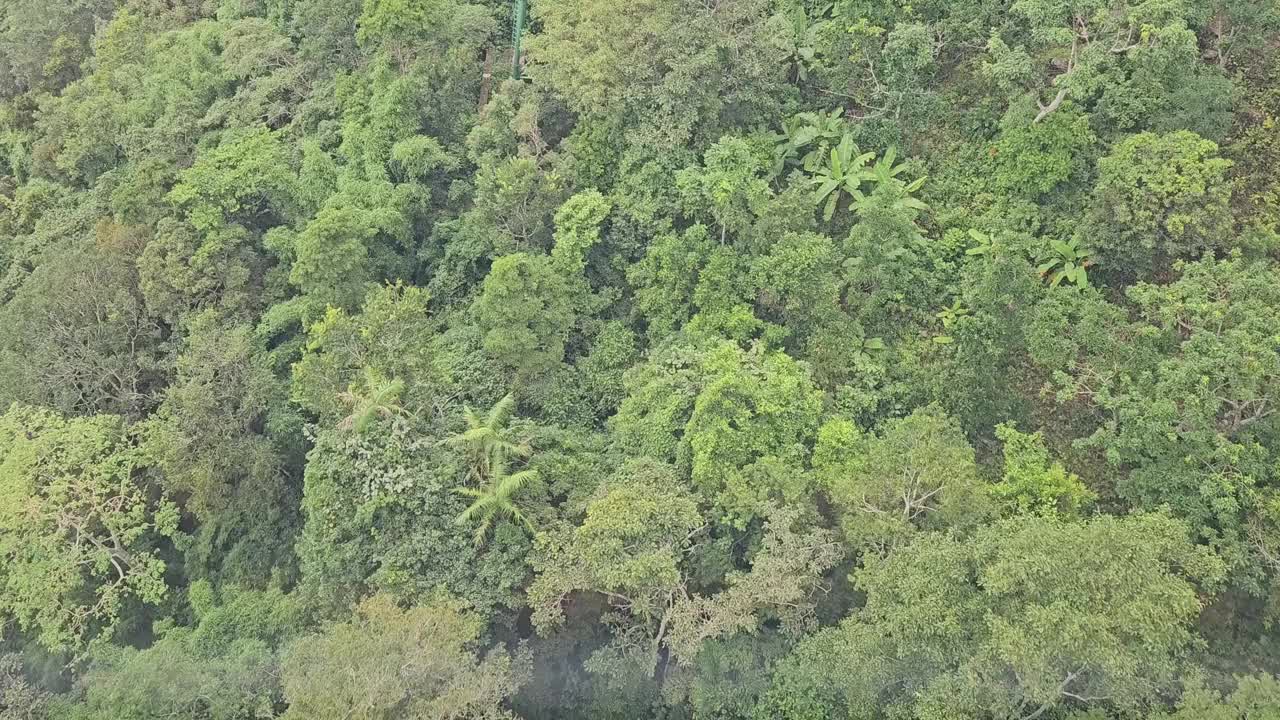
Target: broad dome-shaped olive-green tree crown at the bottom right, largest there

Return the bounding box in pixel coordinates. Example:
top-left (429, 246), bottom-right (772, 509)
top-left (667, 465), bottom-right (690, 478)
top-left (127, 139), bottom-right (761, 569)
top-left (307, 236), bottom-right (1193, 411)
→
top-left (765, 515), bottom-right (1222, 717)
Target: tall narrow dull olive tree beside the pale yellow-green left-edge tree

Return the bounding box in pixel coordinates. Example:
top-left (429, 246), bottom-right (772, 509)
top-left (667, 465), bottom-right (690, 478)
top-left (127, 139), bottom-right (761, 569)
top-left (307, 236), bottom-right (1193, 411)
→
top-left (143, 311), bottom-right (302, 585)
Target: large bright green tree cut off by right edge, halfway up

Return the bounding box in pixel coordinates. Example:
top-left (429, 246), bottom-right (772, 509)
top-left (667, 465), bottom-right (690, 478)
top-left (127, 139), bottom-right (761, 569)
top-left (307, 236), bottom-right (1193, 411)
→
top-left (1038, 258), bottom-right (1280, 556)
